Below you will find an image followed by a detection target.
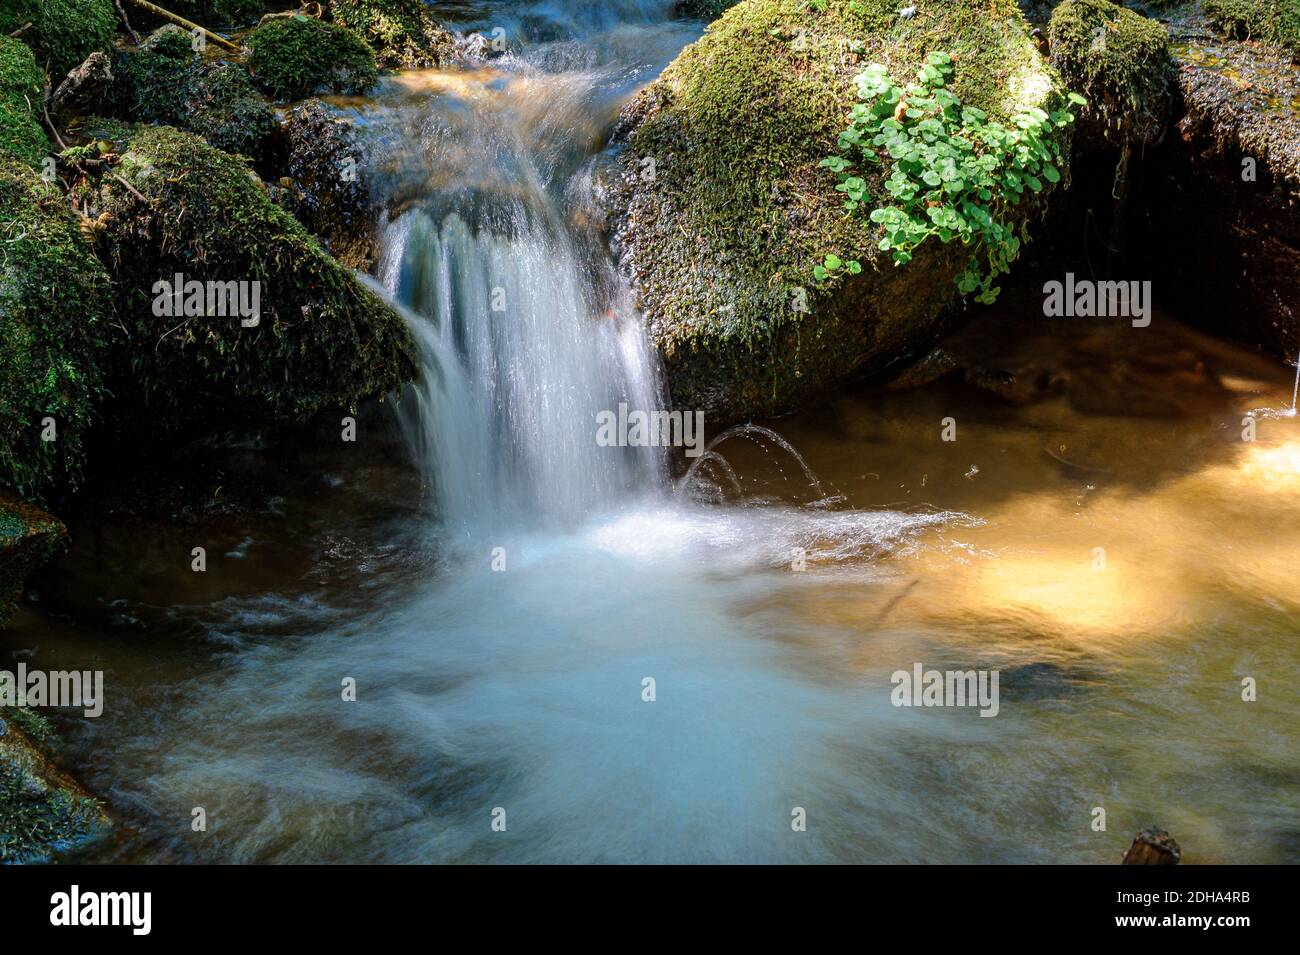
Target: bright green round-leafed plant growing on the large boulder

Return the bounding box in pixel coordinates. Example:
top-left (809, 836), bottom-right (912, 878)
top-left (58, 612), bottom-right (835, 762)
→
top-left (813, 52), bottom-right (1083, 303)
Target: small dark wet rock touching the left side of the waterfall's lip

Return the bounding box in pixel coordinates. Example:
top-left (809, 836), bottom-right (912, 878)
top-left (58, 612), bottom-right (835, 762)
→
top-left (282, 100), bottom-right (380, 269)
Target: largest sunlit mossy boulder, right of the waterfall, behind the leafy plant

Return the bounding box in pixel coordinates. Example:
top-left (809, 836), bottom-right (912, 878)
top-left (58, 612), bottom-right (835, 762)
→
top-left (611, 0), bottom-right (1062, 425)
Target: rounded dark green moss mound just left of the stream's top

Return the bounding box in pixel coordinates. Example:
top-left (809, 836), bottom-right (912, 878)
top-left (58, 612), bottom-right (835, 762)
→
top-left (246, 16), bottom-right (377, 100)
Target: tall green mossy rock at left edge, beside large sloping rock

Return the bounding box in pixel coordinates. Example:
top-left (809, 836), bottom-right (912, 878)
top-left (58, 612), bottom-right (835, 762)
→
top-left (0, 156), bottom-right (112, 496)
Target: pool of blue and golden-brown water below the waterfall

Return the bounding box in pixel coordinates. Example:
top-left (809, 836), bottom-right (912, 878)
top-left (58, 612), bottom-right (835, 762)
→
top-left (10, 304), bottom-right (1300, 863)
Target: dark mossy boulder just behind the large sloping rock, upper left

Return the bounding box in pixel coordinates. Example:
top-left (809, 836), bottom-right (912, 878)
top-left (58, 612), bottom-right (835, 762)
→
top-left (113, 25), bottom-right (276, 161)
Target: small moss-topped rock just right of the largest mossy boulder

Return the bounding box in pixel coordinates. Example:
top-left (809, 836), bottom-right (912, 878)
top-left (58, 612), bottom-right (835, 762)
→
top-left (1049, 0), bottom-right (1175, 143)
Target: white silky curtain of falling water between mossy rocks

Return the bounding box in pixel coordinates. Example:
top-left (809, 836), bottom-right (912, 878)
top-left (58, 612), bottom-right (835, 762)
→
top-left (386, 210), bottom-right (664, 534)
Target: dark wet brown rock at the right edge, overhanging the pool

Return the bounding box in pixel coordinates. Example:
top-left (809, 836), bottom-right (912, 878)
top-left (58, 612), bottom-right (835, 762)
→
top-left (1147, 40), bottom-right (1300, 360)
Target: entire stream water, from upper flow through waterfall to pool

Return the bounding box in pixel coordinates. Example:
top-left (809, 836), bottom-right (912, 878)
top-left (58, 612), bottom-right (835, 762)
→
top-left (0, 0), bottom-right (1300, 863)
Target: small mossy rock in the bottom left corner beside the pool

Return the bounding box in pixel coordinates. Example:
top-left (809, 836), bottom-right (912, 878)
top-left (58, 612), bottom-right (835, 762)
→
top-left (0, 707), bottom-right (108, 865)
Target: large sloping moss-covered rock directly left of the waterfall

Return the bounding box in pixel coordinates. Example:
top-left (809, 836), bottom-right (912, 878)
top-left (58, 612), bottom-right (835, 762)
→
top-left (91, 126), bottom-right (415, 433)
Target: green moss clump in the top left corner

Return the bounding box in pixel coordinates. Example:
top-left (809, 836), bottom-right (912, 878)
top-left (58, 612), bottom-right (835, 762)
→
top-left (0, 0), bottom-right (117, 86)
